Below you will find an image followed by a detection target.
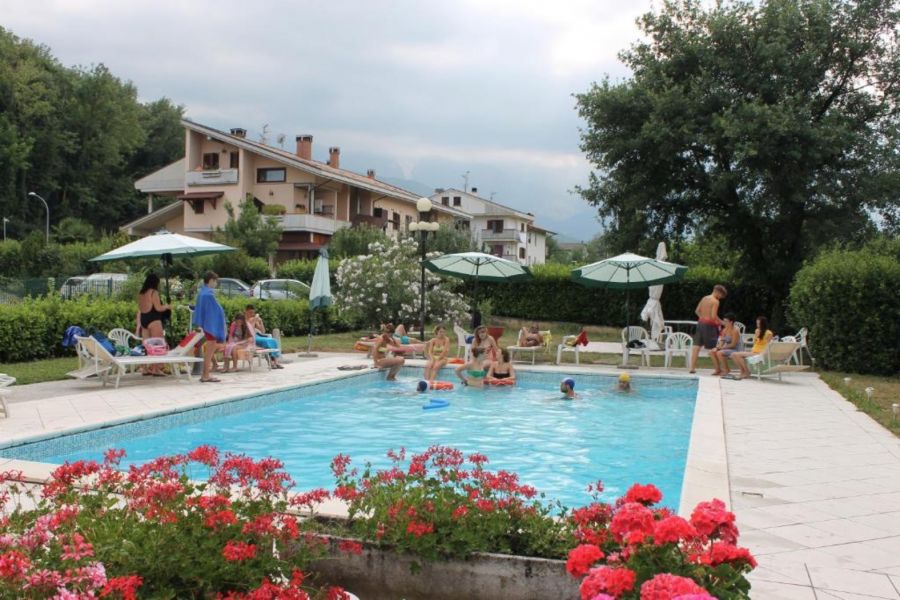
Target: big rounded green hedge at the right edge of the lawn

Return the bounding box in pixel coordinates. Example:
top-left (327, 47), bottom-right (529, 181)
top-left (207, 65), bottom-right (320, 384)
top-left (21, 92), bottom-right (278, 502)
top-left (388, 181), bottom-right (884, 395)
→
top-left (790, 250), bottom-right (900, 375)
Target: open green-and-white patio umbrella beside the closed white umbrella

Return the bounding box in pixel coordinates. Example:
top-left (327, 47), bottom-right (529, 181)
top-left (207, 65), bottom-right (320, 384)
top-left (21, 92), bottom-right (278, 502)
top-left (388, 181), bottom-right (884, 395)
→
top-left (572, 252), bottom-right (687, 327)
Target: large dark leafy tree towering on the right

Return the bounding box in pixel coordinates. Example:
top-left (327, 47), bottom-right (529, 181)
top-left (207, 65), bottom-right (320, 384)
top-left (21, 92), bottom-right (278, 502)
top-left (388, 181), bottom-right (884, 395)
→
top-left (577, 0), bottom-right (900, 316)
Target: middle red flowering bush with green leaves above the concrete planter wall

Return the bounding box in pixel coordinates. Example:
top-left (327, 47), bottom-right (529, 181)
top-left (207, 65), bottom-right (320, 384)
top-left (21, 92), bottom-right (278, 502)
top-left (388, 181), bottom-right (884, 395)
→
top-left (332, 446), bottom-right (572, 559)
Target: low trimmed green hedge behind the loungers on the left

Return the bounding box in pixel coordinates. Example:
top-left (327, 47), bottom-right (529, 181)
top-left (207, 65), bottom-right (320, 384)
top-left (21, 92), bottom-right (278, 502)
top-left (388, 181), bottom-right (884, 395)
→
top-left (0, 296), bottom-right (351, 363)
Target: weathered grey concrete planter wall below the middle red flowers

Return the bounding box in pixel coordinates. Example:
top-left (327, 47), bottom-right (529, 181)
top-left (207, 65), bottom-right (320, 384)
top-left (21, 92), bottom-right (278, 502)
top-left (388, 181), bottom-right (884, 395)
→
top-left (310, 538), bottom-right (579, 600)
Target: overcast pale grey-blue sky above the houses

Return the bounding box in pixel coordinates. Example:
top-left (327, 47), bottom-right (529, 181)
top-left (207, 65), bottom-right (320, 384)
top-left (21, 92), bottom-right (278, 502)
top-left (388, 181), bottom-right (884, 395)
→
top-left (0, 0), bottom-right (651, 239)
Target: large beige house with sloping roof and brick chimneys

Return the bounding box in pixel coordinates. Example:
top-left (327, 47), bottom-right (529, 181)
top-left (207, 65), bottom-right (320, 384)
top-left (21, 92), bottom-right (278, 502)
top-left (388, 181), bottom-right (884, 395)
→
top-left (130, 119), bottom-right (470, 260)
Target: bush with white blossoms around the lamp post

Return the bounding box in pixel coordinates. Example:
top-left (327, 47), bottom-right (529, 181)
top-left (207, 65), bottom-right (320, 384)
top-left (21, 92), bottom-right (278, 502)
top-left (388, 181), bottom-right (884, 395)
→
top-left (335, 238), bottom-right (469, 327)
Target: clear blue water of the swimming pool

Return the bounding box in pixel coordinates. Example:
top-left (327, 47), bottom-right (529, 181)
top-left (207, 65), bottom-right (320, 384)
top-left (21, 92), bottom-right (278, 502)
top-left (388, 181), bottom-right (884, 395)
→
top-left (0, 368), bottom-right (697, 509)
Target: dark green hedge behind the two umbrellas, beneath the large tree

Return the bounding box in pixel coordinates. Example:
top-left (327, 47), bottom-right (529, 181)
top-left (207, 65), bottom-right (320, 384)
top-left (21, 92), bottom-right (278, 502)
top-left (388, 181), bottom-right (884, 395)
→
top-left (478, 263), bottom-right (775, 327)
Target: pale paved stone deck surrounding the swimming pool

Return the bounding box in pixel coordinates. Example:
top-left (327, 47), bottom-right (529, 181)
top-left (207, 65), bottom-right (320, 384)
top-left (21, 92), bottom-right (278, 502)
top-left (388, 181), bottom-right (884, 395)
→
top-left (0, 353), bottom-right (900, 600)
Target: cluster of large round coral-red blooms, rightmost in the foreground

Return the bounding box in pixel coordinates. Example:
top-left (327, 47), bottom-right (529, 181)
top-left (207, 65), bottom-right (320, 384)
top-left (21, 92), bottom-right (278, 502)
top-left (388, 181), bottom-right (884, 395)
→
top-left (566, 485), bottom-right (756, 600)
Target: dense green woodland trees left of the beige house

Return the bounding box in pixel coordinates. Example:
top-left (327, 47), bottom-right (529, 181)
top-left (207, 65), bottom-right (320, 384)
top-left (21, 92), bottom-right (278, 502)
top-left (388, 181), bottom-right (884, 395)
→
top-left (0, 27), bottom-right (184, 238)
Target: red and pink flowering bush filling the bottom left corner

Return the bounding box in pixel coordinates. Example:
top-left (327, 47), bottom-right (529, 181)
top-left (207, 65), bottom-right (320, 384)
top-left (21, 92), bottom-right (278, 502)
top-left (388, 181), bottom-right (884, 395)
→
top-left (0, 447), bottom-right (347, 600)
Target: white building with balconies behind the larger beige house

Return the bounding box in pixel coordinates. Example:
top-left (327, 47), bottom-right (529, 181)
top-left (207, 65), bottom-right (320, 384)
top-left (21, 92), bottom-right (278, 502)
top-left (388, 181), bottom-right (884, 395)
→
top-left (431, 188), bottom-right (553, 265)
